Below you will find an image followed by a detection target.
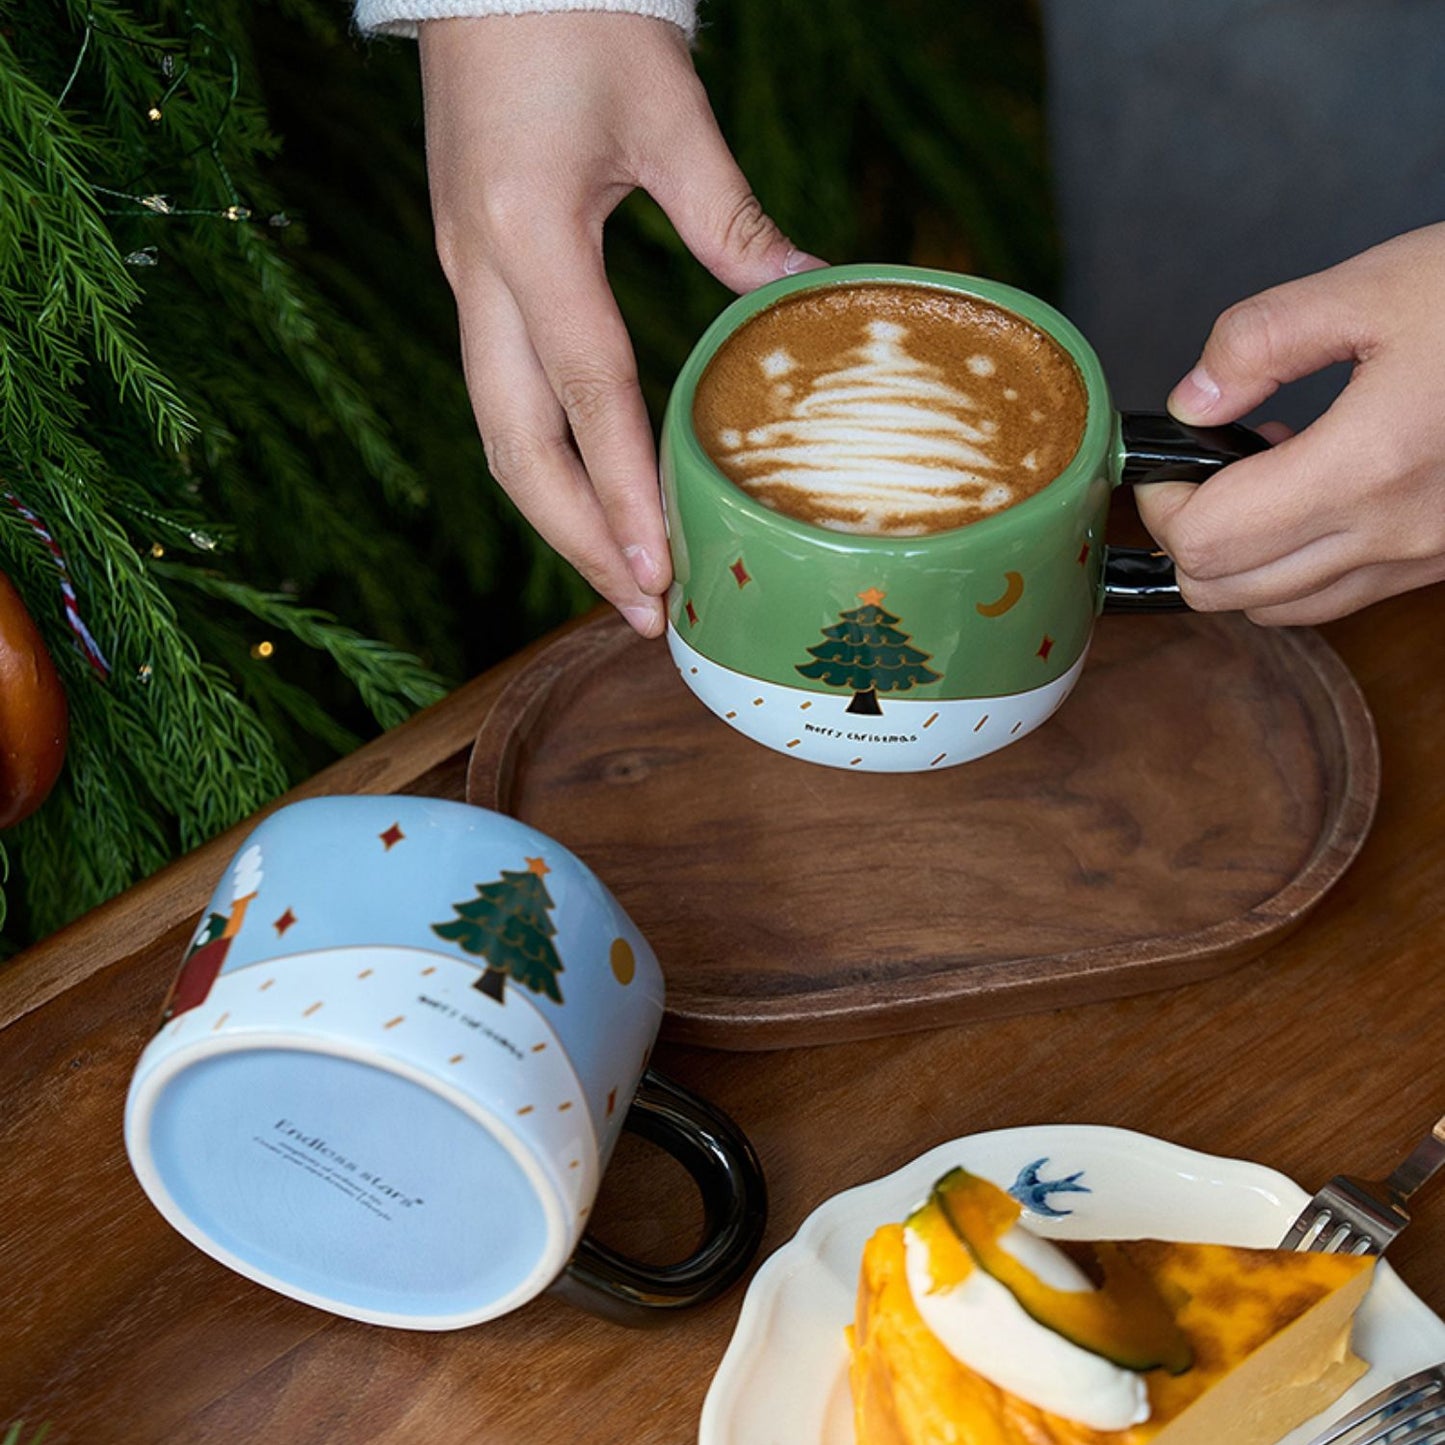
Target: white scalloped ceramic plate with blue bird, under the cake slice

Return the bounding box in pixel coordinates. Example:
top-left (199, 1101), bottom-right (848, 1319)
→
top-left (698, 1124), bottom-right (1445, 1445)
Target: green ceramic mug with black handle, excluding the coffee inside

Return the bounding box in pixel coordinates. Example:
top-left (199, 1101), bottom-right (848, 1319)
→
top-left (660, 264), bottom-right (1266, 772)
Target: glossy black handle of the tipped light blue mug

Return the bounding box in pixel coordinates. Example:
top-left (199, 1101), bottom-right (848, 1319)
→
top-left (552, 1069), bottom-right (767, 1325)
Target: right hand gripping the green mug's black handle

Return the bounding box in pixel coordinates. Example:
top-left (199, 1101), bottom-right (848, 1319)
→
top-left (1139, 224), bottom-right (1445, 624)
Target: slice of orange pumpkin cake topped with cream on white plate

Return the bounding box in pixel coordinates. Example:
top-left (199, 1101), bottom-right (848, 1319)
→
top-left (848, 1169), bottom-right (1374, 1445)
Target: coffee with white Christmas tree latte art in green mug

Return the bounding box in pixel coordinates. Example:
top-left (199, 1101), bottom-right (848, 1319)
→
top-left (692, 282), bottom-right (1087, 536)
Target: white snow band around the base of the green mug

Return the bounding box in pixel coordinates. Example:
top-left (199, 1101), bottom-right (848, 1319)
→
top-left (668, 623), bottom-right (1088, 773)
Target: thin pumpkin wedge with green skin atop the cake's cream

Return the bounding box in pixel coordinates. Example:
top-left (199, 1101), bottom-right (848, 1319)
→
top-left (925, 1169), bottom-right (1194, 1374)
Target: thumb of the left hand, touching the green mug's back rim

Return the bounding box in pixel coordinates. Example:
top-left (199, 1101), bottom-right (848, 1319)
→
top-left (646, 110), bottom-right (828, 292)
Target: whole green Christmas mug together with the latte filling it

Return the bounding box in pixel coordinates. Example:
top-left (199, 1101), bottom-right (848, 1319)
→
top-left (659, 264), bottom-right (1266, 772)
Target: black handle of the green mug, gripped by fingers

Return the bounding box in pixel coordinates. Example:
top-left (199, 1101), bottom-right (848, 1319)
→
top-left (1104, 412), bottom-right (1269, 613)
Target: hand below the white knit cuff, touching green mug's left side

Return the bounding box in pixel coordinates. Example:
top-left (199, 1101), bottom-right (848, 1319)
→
top-left (419, 12), bottom-right (822, 637)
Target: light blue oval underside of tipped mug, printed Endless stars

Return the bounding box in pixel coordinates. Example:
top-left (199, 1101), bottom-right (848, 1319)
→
top-left (126, 1038), bottom-right (566, 1329)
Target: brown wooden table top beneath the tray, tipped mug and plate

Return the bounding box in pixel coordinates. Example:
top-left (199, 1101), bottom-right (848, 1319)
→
top-left (0, 588), bottom-right (1445, 1445)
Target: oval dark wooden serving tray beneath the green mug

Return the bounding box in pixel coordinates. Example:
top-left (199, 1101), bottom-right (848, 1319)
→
top-left (467, 614), bottom-right (1380, 1049)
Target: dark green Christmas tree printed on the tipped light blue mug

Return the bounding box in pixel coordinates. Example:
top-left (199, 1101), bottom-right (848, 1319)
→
top-left (432, 858), bottom-right (562, 1003)
